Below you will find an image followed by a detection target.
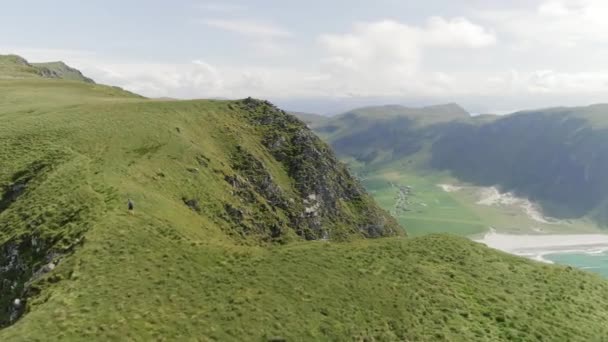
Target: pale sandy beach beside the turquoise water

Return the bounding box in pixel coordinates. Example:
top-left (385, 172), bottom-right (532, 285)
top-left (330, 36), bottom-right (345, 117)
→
top-left (475, 231), bottom-right (608, 263)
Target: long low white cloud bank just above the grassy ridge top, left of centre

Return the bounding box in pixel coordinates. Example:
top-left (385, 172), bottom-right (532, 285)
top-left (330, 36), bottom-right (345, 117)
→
top-left (82, 60), bottom-right (326, 98)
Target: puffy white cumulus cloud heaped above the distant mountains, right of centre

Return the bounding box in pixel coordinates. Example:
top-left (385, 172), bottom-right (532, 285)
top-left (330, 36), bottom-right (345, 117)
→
top-left (319, 17), bottom-right (496, 96)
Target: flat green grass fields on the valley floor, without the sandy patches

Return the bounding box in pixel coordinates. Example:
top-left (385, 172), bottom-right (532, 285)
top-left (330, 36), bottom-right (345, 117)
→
top-left (359, 163), bottom-right (599, 237)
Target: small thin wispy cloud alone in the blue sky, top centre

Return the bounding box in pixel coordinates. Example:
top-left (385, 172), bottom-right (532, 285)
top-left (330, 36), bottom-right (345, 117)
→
top-left (203, 19), bottom-right (292, 38)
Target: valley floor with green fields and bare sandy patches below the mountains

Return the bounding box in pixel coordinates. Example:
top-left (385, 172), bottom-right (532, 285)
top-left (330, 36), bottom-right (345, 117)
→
top-left (352, 163), bottom-right (602, 237)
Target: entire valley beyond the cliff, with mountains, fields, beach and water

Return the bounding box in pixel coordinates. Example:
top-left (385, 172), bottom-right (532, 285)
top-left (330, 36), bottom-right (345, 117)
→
top-left (306, 104), bottom-right (608, 275)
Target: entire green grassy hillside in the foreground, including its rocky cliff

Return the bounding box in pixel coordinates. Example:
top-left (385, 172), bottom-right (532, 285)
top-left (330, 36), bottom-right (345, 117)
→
top-left (0, 57), bottom-right (608, 341)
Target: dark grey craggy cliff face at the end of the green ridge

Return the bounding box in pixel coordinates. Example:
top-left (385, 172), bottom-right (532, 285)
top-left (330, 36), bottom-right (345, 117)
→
top-left (239, 98), bottom-right (402, 240)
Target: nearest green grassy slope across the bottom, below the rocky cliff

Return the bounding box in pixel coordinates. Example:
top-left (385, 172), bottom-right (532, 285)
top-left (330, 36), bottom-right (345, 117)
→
top-left (5, 231), bottom-right (608, 341)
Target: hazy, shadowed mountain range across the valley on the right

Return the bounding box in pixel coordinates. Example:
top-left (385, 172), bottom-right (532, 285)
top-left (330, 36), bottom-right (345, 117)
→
top-left (315, 105), bottom-right (608, 225)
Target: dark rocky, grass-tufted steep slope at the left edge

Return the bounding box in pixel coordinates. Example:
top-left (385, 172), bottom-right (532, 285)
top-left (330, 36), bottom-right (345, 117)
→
top-left (0, 155), bottom-right (95, 327)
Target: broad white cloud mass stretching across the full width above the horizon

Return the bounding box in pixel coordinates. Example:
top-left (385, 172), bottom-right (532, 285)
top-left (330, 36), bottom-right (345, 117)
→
top-left (8, 0), bottom-right (608, 110)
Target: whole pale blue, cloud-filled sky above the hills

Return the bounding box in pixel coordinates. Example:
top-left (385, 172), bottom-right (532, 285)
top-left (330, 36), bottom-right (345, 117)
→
top-left (0, 0), bottom-right (608, 114)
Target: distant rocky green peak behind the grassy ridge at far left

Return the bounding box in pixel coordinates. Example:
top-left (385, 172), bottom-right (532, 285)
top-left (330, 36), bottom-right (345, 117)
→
top-left (0, 55), bottom-right (95, 83)
